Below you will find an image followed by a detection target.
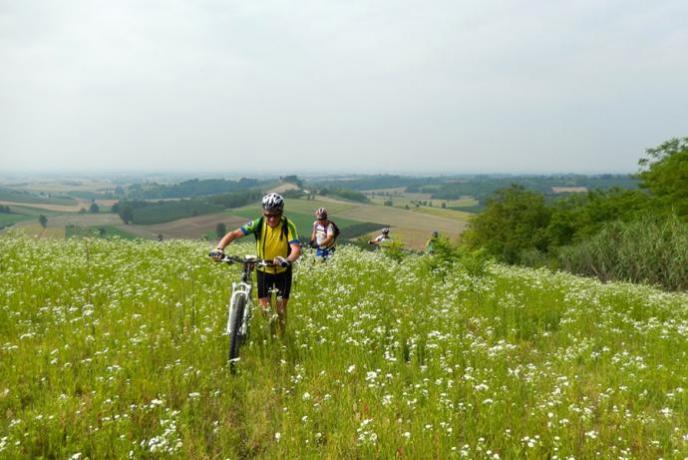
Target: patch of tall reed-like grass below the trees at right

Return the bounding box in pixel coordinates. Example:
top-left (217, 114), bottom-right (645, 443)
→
top-left (559, 215), bottom-right (688, 290)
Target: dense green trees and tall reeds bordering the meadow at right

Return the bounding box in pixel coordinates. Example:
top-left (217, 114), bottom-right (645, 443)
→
top-left (462, 137), bottom-right (688, 289)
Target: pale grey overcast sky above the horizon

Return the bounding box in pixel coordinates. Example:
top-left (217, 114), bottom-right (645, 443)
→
top-left (0, 0), bottom-right (688, 173)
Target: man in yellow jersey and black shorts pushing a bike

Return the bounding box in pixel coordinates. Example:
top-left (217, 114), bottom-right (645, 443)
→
top-left (215, 193), bottom-right (301, 331)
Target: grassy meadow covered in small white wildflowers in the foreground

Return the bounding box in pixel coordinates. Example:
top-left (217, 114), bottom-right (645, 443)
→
top-left (0, 233), bottom-right (688, 458)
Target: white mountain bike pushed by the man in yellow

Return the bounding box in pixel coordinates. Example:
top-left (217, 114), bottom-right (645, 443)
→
top-left (210, 252), bottom-right (284, 373)
